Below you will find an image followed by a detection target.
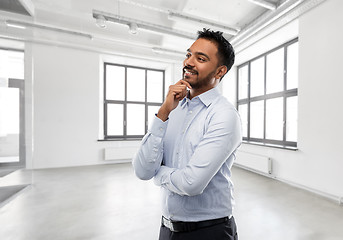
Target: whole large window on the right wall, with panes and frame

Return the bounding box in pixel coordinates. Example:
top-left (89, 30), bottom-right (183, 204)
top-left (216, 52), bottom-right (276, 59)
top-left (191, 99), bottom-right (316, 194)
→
top-left (237, 39), bottom-right (298, 147)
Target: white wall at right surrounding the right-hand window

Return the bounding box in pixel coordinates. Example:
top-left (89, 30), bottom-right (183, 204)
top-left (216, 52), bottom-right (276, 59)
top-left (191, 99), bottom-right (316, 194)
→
top-left (238, 0), bottom-right (343, 201)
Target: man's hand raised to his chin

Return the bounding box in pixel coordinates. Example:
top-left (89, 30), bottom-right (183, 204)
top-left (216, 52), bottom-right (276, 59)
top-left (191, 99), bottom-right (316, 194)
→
top-left (157, 80), bottom-right (192, 121)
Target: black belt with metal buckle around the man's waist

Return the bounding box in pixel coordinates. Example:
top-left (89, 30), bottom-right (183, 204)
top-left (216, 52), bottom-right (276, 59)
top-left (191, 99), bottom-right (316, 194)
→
top-left (162, 216), bottom-right (230, 232)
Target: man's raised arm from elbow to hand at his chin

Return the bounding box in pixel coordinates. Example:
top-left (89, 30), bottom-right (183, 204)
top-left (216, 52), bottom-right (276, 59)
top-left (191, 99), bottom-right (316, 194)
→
top-left (133, 80), bottom-right (191, 180)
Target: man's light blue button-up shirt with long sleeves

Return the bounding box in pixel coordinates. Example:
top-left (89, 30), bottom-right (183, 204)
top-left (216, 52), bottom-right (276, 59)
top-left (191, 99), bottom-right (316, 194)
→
top-left (133, 88), bottom-right (242, 221)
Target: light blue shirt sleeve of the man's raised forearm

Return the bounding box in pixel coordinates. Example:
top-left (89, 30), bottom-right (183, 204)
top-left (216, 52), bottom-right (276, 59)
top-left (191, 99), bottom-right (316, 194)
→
top-left (132, 116), bottom-right (168, 180)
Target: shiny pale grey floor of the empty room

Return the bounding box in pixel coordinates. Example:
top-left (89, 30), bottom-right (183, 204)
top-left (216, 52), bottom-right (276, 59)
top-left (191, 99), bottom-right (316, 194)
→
top-left (0, 164), bottom-right (343, 240)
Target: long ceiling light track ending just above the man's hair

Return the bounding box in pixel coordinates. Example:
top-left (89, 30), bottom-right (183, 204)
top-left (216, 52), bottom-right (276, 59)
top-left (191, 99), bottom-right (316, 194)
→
top-left (93, 10), bottom-right (196, 40)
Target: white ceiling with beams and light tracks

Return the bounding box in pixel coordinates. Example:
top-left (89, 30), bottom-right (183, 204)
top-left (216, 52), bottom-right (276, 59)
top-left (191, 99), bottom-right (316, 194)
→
top-left (0, 0), bottom-right (326, 61)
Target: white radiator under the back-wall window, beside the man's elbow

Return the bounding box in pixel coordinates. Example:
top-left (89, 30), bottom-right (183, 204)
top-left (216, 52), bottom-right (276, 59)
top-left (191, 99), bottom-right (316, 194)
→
top-left (104, 147), bottom-right (138, 162)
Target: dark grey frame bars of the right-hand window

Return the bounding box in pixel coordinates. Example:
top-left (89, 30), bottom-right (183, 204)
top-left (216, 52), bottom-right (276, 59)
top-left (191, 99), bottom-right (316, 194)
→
top-left (237, 39), bottom-right (298, 147)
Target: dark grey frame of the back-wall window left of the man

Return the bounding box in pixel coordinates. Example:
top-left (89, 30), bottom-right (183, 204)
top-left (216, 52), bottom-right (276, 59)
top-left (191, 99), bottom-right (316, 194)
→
top-left (103, 62), bottom-right (166, 140)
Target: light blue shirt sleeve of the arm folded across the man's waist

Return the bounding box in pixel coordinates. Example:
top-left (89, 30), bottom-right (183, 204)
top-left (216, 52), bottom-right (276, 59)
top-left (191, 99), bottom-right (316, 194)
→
top-left (154, 110), bottom-right (242, 196)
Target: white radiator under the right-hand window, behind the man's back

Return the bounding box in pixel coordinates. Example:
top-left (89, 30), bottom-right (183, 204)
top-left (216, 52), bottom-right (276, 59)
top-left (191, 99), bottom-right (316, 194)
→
top-left (235, 151), bottom-right (272, 174)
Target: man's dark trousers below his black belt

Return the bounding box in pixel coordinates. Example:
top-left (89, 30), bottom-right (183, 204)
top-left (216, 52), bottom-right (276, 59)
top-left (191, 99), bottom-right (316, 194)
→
top-left (159, 217), bottom-right (238, 240)
